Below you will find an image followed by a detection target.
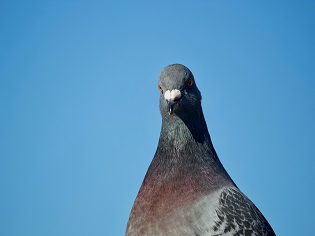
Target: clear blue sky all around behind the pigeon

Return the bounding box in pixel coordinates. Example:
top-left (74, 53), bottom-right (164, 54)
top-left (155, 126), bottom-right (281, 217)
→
top-left (0, 0), bottom-right (315, 236)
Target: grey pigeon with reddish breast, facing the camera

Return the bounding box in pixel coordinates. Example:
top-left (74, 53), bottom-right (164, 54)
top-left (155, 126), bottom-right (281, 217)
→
top-left (125, 64), bottom-right (275, 236)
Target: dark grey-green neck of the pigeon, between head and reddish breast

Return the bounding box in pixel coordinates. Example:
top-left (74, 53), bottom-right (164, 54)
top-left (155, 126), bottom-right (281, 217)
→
top-left (152, 106), bottom-right (224, 176)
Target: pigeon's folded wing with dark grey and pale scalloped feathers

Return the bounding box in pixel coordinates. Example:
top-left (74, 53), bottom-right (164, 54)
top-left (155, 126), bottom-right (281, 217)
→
top-left (213, 188), bottom-right (275, 236)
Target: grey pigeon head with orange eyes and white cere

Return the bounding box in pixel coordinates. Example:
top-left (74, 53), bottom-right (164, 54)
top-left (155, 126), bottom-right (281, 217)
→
top-left (158, 64), bottom-right (201, 117)
